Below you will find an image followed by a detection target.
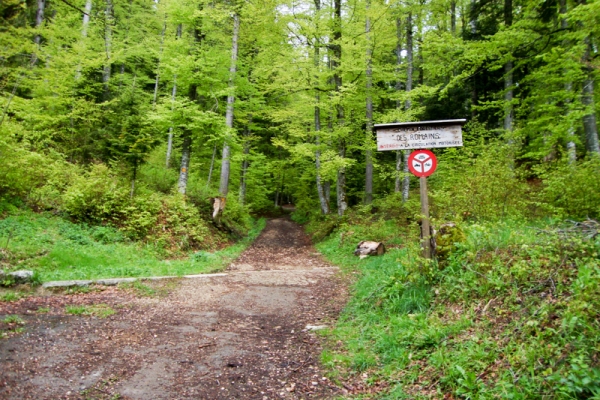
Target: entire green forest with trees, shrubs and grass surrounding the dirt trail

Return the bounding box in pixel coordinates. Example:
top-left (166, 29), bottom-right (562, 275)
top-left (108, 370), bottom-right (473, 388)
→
top-left (0, 0), bottom-right (600, 399)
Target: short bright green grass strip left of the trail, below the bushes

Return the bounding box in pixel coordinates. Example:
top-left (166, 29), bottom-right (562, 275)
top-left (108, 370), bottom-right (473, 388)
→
top-left (0, 211), bottom-right (266, 282)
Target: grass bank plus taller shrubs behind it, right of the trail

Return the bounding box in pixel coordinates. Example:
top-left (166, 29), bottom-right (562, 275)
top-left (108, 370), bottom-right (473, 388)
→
top-left (308, 152), bottom-right (600, 399)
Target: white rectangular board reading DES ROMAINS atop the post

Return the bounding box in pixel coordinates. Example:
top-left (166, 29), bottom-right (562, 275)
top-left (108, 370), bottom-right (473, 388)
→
top-left (375, 120), bottom-right (464, 151)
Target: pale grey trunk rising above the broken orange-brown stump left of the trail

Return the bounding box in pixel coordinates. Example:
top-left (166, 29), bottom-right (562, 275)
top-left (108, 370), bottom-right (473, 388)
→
top-left (219, 13), bottom-right (240, 197)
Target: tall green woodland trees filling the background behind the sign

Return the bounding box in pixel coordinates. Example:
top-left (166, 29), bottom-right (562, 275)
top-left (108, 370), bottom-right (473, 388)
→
top-left (0, 0), bottom-right (600, 241)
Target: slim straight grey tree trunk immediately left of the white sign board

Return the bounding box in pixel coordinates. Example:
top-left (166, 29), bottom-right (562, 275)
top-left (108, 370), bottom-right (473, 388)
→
top-left (365, 0), bottom-right (373, 204)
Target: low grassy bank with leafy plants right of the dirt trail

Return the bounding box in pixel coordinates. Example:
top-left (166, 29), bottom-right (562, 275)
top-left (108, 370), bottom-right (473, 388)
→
top-left (317, 221), bottom-right (600, 399)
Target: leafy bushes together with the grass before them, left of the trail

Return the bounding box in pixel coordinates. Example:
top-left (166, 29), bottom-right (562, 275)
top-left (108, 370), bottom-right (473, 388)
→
top-left (0, 140), bottom-right (264, 281)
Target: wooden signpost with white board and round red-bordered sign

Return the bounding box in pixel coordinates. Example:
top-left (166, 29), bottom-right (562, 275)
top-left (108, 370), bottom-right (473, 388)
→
top-left (374, 119), bottom-right (466, 259)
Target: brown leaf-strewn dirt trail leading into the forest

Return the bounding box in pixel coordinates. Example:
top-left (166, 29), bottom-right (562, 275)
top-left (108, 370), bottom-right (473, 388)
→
top-left (0, 218), bottom-right (345, 399)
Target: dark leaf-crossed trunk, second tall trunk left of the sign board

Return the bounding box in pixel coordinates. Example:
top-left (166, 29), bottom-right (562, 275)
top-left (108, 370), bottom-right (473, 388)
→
top-left (331, 0), bottom-right (348, 217)
